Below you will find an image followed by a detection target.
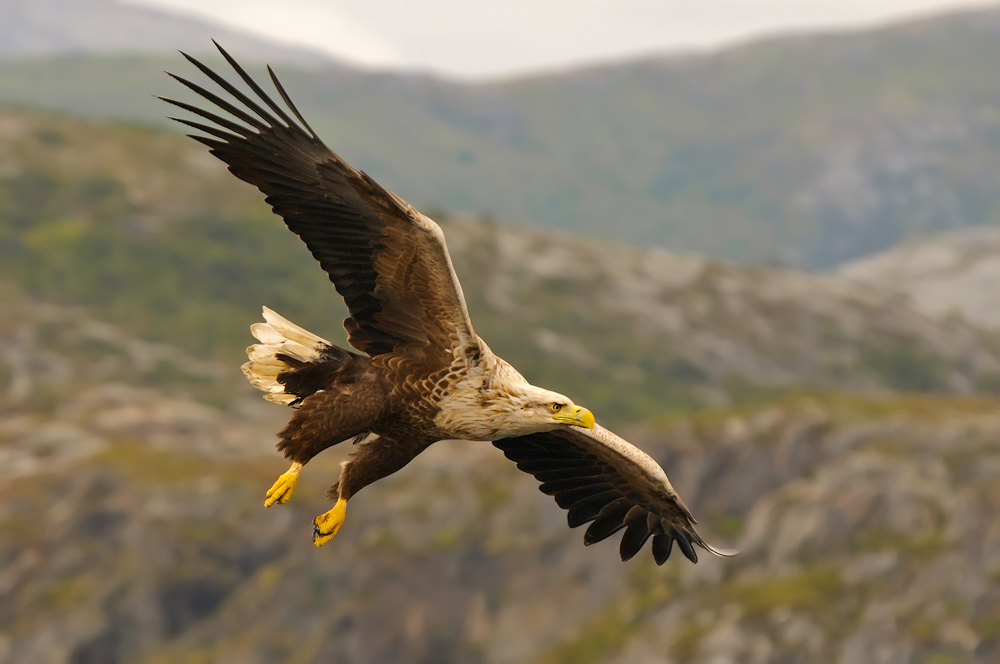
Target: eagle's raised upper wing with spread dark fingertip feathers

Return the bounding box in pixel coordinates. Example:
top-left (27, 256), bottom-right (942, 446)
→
top-left (164, 44), bottom-right (476, 361)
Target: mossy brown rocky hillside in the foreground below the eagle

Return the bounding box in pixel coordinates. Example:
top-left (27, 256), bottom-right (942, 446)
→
top-left (0, 301), bottom-right (1000, 664)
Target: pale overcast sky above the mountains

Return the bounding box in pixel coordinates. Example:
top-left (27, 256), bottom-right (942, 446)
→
top-left (121, 0), bottom-right (998, 78)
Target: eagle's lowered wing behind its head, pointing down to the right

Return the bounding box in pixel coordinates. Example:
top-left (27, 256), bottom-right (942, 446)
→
top-left (493, 425), bottom-right (735, 565)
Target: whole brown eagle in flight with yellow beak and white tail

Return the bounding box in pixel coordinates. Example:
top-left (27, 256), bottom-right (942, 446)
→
top-left (160, 44), bottom-right (733, 565)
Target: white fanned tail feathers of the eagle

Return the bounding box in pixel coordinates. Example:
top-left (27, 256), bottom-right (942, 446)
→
top-left (242, 307), bottom-right (331, 404)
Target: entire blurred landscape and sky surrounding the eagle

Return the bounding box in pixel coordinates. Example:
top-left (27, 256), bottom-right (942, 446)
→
top-left (0, 0), bottom-right (1000, 664)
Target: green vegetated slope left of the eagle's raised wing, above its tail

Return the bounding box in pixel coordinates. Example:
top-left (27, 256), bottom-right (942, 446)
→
top-left (0, 111), bottom-right (340, 361)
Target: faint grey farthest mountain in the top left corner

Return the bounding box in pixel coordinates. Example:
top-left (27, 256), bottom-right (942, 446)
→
top-left (0, 0), bottom-right (332, 66)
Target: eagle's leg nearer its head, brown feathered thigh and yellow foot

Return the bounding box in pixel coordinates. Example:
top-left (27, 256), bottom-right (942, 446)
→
top-left (313, 436), bottom-right (434, 546)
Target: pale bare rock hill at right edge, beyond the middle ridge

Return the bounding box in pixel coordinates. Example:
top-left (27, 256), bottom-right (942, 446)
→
top-left (838, 228), bottom-right (1000, 330)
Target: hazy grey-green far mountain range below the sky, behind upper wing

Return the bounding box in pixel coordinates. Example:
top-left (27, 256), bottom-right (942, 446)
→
top-left (0, 10), bottom-right (1000, 269)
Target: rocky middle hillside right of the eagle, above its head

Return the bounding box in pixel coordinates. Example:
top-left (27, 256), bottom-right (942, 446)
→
top-left (445, 217), bottom-right (1000, 418)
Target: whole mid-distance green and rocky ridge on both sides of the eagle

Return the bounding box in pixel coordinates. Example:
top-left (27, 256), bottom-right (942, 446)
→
top-left (0, 104), bottom-right (1000, 422)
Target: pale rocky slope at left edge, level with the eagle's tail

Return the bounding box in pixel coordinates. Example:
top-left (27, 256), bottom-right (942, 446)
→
top-left (0, 282), bottom-right (278, 481)
